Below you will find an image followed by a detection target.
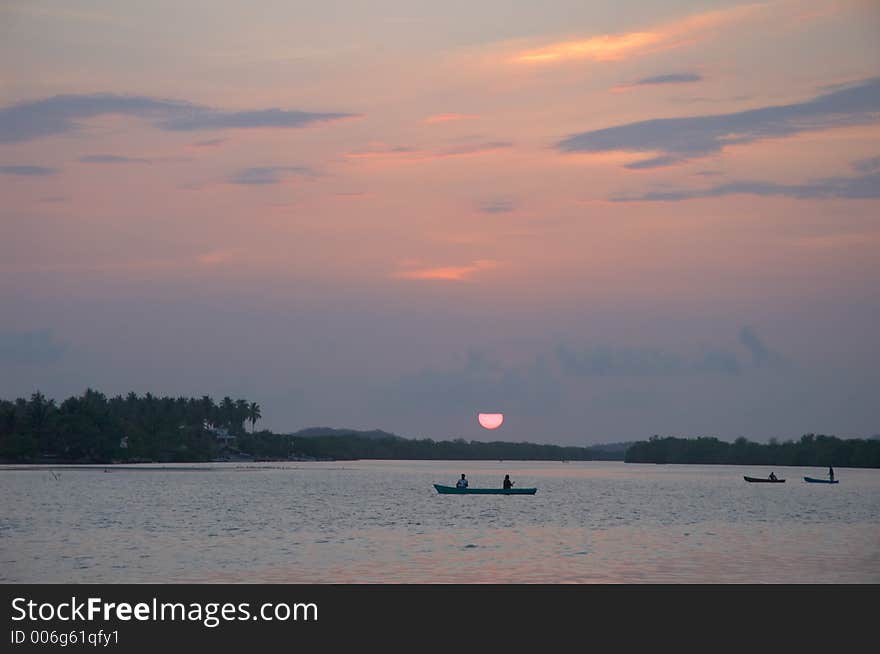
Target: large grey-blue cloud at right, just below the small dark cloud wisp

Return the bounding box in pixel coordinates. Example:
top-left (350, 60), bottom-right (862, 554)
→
top-left (556, 77), bottom-right (880, 163)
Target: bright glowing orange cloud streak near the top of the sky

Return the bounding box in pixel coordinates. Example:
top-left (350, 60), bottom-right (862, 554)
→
top-left (514, 4), bottom-right (765, 64)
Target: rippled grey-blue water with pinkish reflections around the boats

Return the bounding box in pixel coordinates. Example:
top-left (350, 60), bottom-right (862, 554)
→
top-left (0, 461), bottom-right (880, 584)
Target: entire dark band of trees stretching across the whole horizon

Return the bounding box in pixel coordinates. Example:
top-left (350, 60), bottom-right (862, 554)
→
top-left (0, 389), bottom-right (880, 468)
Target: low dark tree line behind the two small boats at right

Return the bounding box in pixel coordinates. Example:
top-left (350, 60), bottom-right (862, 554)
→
top-left (624, 434), bottom-right (880, 468)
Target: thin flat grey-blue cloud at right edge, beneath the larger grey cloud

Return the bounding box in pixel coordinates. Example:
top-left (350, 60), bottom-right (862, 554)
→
top-left (610, 171), bottom-right (880, 202)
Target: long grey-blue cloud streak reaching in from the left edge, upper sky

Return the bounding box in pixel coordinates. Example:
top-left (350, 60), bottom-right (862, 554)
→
top-left (0, 93), bottom-right (354, 143)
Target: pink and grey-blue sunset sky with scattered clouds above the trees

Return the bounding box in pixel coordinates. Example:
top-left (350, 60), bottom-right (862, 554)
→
top-left (0, 0), bottom-right (880, 446)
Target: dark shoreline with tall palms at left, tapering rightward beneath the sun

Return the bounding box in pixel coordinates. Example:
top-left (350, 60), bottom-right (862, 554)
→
top-left (0, 389), bottom-right (622, 463)
